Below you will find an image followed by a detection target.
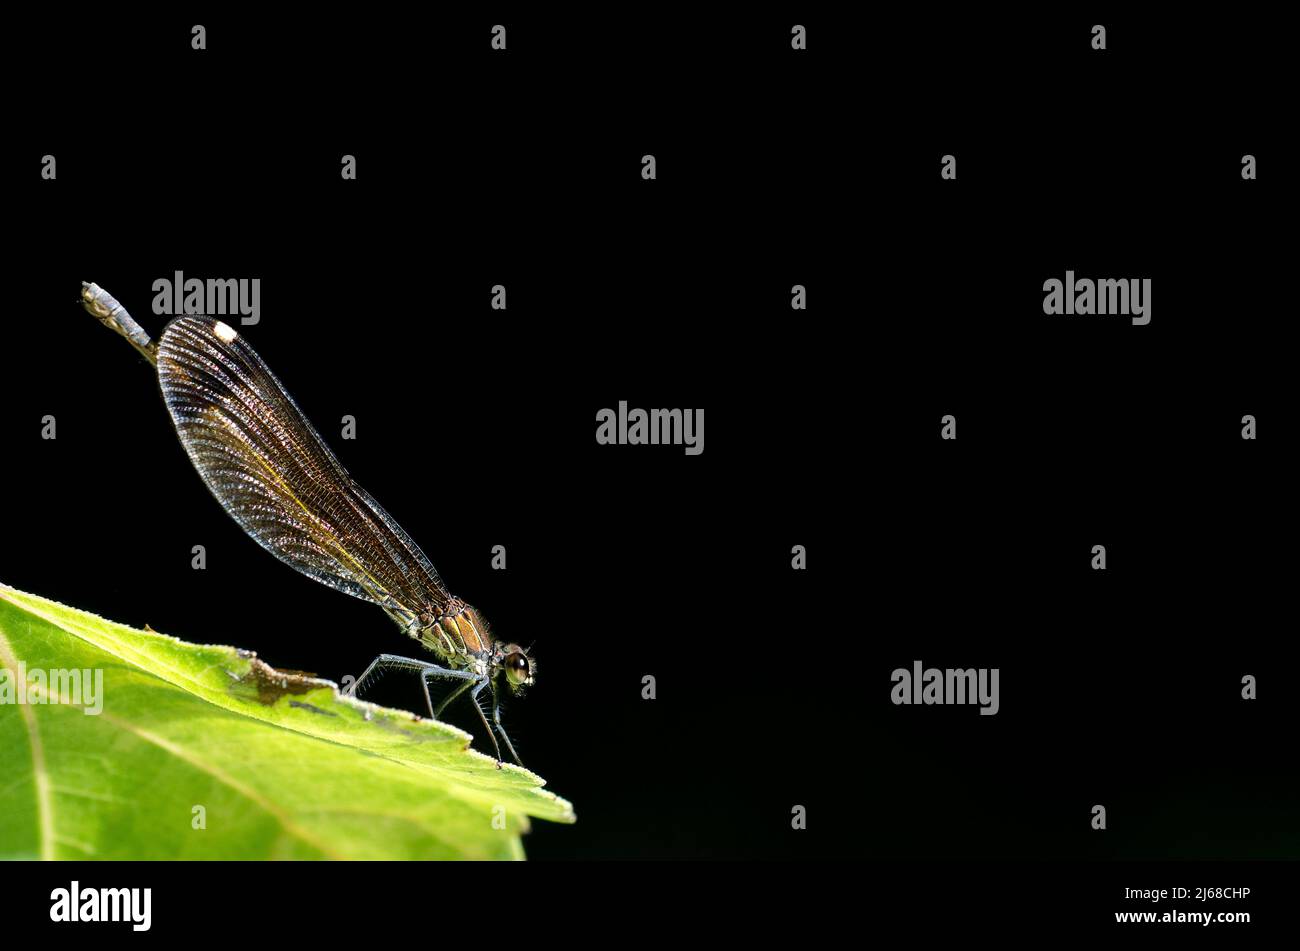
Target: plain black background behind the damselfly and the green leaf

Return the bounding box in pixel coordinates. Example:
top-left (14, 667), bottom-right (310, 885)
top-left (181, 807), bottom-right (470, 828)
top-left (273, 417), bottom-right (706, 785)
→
top-left (0, 3), bottom-right (1300, 883)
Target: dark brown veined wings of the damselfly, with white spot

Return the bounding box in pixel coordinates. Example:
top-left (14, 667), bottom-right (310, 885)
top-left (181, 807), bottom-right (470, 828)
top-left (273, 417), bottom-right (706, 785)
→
top-left (157, 317), bottom-right (452, 631)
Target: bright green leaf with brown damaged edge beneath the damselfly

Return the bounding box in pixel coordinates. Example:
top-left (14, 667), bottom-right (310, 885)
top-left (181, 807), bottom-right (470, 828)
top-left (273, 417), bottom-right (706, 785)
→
top-left (0, 585), bottom-right (573, 859)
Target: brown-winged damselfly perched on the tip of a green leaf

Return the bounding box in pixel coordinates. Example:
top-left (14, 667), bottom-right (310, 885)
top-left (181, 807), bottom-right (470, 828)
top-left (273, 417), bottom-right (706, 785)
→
top-left (82, 282), bottom-right (536, 767)
